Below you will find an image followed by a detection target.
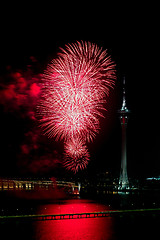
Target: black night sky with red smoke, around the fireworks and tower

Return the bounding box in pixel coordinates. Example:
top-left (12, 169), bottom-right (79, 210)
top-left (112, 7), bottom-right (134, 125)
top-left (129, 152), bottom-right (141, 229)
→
top-left (0, 2), bottom-right (160, 178)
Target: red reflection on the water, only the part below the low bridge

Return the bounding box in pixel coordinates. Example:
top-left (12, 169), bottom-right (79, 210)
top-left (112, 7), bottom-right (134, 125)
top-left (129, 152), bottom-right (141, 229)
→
top-left (35, 218), bottom-right (113, 240)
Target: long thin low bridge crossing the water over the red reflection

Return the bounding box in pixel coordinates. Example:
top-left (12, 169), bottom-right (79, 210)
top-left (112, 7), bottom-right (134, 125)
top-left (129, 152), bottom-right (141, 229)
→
top-left (0, 208), bottom-right (160, 221)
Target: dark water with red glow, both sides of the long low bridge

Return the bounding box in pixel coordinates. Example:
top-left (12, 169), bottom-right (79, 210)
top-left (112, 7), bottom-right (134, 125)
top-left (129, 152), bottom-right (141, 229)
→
top-left (0, 195), bottom-right (160, 240)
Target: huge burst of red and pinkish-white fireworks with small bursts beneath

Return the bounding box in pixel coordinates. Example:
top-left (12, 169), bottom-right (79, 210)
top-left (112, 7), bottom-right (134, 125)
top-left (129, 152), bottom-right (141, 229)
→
top-left (39, 42), bottom-right (116, 172)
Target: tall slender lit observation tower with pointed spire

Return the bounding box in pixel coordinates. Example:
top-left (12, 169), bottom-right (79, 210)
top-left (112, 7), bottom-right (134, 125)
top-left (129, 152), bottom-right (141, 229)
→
top-left (118, 77), bottom-right (130, 190)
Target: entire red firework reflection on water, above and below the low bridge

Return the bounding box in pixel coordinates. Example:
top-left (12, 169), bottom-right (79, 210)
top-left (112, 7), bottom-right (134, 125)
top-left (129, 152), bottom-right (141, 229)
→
top-left (35, 200), bottom-right (113, 240)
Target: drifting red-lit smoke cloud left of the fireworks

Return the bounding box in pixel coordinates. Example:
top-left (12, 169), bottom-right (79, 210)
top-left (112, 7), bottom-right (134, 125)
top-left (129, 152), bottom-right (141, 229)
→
top-left (0, 57), bottom-right (61, 175)
